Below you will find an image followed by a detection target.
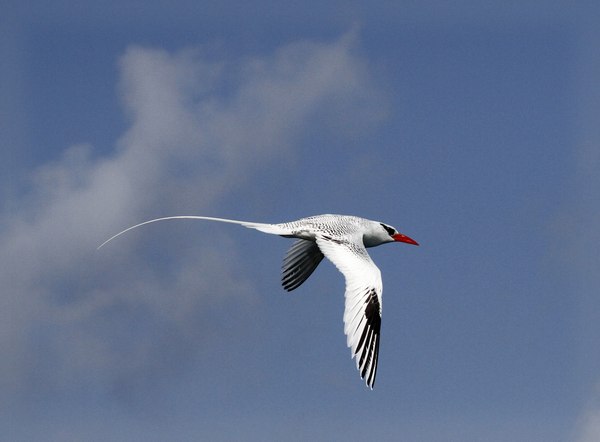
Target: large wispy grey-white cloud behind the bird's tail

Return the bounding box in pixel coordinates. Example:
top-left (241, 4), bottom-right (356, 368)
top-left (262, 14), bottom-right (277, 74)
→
top-left (0, 35), bottom-right (374, 406)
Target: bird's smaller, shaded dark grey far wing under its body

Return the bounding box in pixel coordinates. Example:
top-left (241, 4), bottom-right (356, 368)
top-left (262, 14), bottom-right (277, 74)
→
top-left (281, 239), bottom-right (323, 292)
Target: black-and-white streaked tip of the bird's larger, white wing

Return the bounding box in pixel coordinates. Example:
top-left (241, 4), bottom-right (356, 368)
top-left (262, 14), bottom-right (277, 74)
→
top-left (355, 289), bottom-right (381, 388)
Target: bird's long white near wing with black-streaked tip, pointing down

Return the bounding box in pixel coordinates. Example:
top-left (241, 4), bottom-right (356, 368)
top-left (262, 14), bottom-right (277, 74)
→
top-left (316, 235), bottom-right (383, 388)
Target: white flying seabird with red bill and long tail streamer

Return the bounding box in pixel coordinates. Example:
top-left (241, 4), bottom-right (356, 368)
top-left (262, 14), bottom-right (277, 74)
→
top-left (98, 214), bottom-right (419, 390)
